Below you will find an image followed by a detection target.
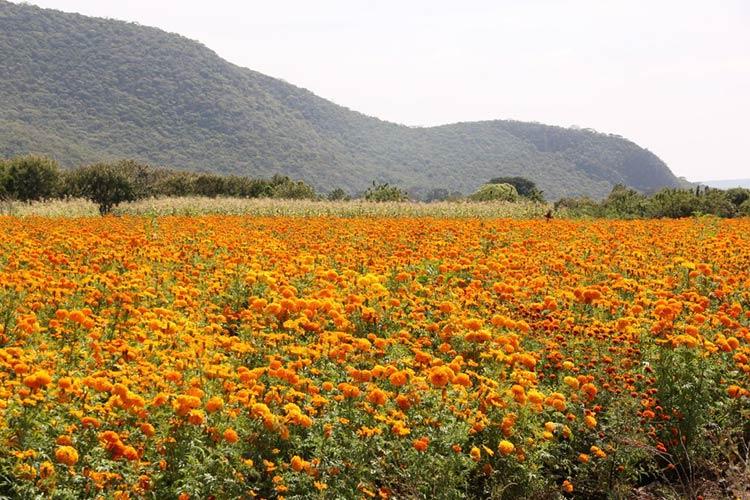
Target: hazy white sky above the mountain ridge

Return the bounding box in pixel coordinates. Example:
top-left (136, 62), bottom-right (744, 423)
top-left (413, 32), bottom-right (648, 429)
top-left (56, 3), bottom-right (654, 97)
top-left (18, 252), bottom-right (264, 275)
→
top-left (13, 0), bottom-right (750, 180)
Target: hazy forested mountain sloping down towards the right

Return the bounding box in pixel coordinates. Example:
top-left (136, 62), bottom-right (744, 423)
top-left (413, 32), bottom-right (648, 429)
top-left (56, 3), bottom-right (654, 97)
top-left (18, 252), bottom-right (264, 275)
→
top-left (0, 0), bottom-right (679, 199)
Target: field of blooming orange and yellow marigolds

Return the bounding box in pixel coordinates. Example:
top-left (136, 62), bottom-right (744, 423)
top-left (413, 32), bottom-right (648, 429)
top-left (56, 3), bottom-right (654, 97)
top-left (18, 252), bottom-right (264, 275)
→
top-left (0, 216), bottom-right (750, 499)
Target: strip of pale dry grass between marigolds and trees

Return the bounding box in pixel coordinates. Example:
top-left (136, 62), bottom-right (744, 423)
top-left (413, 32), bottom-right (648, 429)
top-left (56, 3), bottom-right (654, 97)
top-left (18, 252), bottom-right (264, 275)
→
top-left (0, 197), bottom-right (549, 219)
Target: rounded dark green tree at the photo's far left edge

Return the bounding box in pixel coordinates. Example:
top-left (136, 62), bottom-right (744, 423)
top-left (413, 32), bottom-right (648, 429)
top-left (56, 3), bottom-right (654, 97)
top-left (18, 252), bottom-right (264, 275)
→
top-left (0, 155), bottom-right (60, 201)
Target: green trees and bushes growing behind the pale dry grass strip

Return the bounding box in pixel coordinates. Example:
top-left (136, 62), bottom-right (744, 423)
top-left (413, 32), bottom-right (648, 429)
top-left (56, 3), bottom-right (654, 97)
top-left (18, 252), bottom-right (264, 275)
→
top-left (0, 155), bottom-right (543, 214)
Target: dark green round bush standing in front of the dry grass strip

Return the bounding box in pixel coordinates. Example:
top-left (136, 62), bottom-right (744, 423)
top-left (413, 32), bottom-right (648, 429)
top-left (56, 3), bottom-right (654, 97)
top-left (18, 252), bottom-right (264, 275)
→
top-left (68, 163), bottom-right (137, 215)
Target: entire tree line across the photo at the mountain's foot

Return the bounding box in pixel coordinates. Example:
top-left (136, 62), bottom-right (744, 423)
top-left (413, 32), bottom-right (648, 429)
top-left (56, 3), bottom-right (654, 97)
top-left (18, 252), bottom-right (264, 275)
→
top-left (0, 155), bottom-right (750, 218)
